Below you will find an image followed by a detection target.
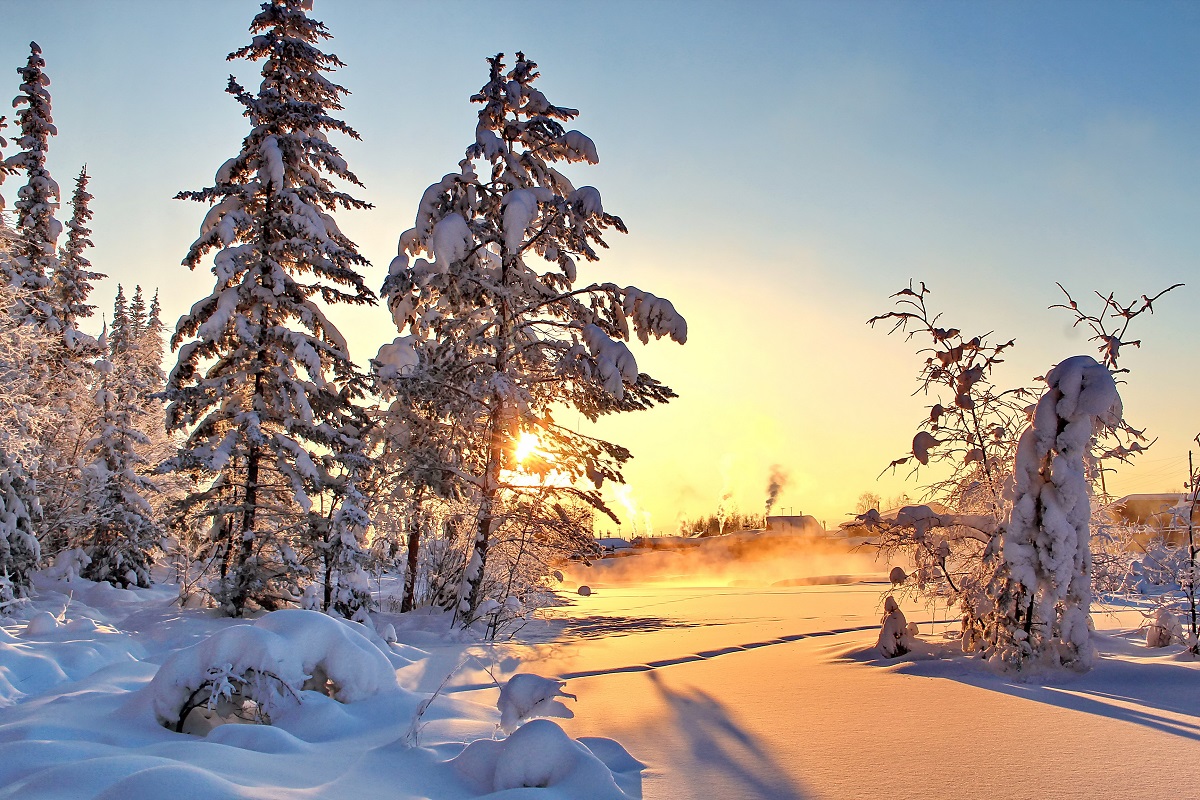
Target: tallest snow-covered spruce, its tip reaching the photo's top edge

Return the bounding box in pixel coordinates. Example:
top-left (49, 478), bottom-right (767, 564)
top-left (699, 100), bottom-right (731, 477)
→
top-left (166, 0), bottom-right (374, 615)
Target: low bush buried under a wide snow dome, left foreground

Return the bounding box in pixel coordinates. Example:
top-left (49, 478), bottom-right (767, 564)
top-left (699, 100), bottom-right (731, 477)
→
top-left (149, 609), bottom-right (400, 732)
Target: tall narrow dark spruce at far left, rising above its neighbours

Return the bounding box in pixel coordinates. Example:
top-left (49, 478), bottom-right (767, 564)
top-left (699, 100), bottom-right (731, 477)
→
top-left (5, 42), bottom-right (62, 331)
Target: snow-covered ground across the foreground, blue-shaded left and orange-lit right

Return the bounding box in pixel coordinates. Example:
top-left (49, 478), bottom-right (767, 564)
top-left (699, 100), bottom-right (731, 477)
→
top-left (0, 540), bottom-right (1200, 800)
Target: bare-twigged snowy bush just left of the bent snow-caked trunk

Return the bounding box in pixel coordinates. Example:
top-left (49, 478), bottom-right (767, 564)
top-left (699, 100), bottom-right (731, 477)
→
top-left (854, 282), bottom-right (1033, 651)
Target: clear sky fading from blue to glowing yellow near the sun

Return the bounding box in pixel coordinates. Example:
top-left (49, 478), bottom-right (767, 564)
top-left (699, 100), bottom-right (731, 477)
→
top-left (0, 0), bottom-right (1200, 531)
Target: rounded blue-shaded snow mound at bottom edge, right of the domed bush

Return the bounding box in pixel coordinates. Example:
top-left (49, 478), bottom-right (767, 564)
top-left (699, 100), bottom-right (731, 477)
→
top-left (450, 720), bottom-right (629, 800)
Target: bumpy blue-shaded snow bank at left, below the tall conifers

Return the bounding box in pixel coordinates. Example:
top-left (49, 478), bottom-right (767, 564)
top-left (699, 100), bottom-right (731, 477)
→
top-left (0, 578), bottom-right (640, 800)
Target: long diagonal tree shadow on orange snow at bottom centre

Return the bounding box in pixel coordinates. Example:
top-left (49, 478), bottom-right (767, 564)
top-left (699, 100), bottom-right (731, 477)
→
top-left (647, 672), bottom-right (805, 800)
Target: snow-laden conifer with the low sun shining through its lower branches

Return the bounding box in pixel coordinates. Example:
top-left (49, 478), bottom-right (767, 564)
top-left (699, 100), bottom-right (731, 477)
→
top-left (380, 53), bottom-right (686, 625)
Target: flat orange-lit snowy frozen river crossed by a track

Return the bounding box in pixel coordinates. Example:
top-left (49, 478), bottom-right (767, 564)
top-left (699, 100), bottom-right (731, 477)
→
top-left (439, 568), bottom-right (1200, 800)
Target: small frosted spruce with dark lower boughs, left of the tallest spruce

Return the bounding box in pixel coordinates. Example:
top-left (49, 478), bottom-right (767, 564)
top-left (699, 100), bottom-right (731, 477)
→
top-left (78, 350), bottom-right (162, 588)
